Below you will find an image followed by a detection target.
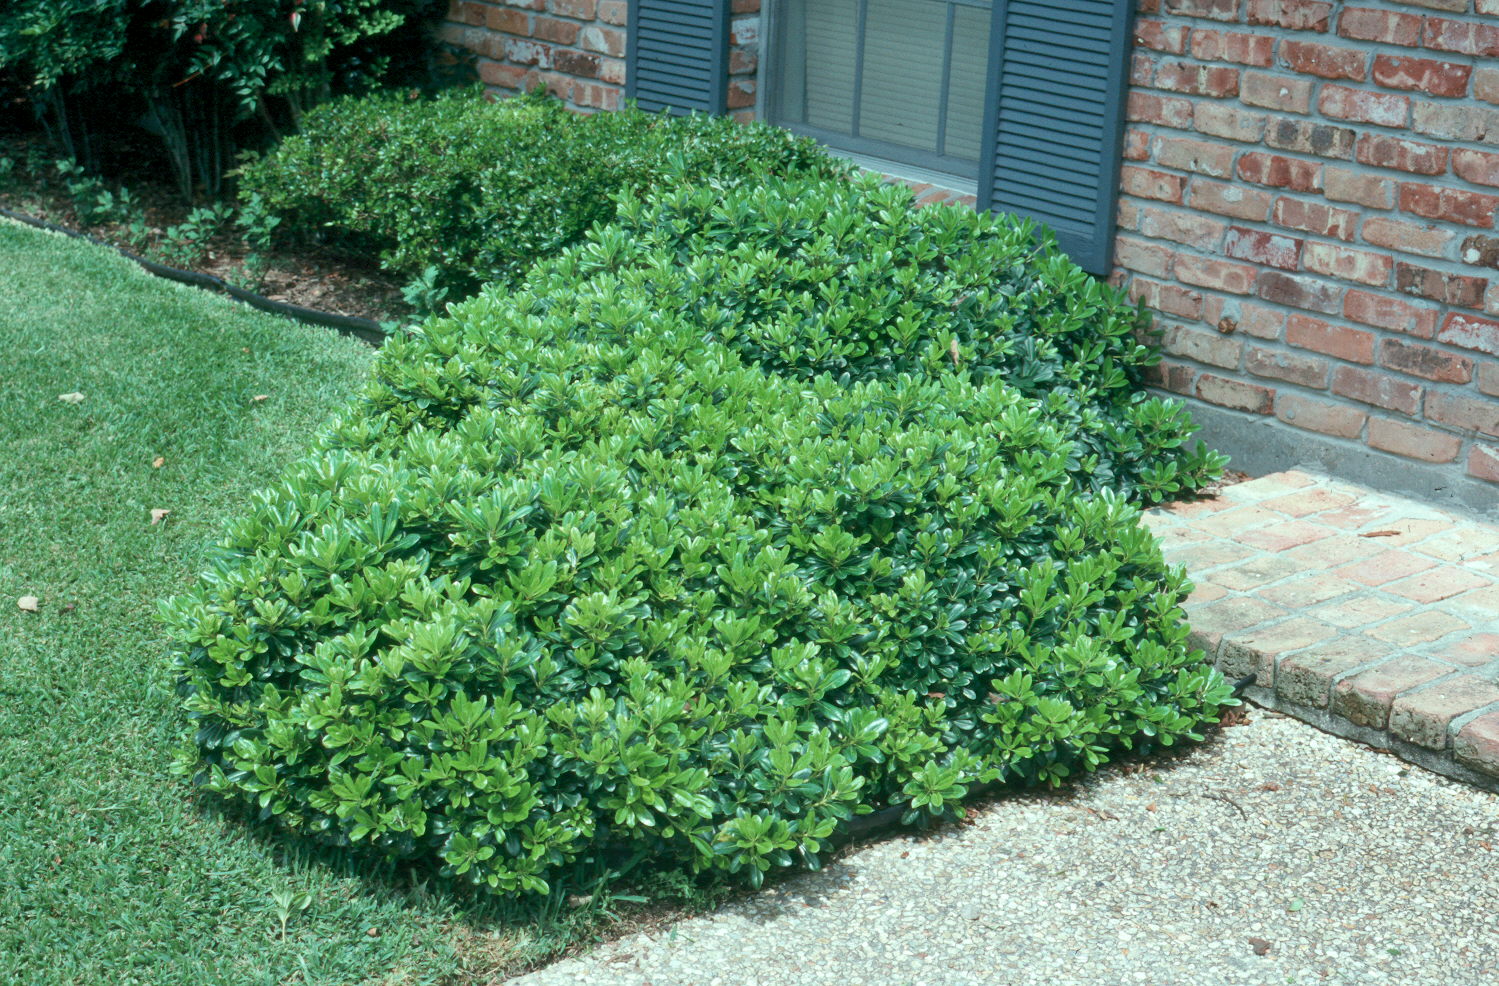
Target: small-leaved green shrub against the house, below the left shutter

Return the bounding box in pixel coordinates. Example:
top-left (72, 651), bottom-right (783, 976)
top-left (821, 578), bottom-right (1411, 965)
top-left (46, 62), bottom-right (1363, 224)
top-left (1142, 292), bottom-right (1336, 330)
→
top-left (230, 90), bottom-right (845, 295)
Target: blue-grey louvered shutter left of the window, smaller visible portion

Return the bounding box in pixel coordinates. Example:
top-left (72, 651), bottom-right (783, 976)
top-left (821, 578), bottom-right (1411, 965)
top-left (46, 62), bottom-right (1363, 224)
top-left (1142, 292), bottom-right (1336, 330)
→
top-left (625, 0), bottom-right (729, 112)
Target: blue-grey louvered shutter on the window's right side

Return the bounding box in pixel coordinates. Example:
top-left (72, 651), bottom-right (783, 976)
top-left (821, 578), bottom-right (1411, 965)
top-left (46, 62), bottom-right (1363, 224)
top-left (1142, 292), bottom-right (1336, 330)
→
top-left (979, 0), bottom-right (1135, 276)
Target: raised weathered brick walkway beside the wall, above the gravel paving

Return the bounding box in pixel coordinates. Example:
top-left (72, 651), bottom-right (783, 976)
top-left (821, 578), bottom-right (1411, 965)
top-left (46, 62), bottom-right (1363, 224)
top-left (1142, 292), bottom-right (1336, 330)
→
top-left (1147, 472), bottom-right (1499, 790)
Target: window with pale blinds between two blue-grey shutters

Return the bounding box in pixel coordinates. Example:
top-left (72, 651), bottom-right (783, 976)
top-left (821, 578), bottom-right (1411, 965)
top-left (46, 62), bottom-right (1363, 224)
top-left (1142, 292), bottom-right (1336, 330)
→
top-left (767, 0), bottom-right (992, 180)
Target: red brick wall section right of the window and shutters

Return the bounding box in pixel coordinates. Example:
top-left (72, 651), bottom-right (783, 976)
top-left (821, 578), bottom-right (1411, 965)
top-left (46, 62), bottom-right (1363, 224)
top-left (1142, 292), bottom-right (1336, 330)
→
top-left (1115, 0), bottom-right (1499, 483)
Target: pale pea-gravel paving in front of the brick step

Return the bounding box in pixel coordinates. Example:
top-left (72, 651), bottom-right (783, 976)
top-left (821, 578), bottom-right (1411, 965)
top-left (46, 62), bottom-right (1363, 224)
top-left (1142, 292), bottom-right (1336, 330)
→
top-left (511, 709), bottom-right (1499, 986)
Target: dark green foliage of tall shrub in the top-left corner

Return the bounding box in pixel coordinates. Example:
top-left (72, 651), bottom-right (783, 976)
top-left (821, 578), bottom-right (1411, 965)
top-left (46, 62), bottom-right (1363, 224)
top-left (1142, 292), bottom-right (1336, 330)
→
top-left (0, 0), bottom-right (447, 198)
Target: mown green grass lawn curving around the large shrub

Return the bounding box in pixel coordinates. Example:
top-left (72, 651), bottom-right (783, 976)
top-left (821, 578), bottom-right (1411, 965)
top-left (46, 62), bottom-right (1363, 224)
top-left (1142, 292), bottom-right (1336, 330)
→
top-left (0, 220), bottom-right (588, 986)
